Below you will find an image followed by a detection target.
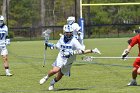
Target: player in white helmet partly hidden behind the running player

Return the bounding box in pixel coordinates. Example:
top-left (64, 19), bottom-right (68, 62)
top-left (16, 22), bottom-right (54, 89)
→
top-left (67, 16), bottom-right (84, 45)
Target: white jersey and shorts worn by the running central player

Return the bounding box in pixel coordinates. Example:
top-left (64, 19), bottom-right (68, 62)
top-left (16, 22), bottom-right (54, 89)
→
top-left (53, 35), bottom-right (84, 74)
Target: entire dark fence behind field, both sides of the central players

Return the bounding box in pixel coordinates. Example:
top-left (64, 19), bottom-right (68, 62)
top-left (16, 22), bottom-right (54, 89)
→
top-left (9, 25), bottom-right (137, 40)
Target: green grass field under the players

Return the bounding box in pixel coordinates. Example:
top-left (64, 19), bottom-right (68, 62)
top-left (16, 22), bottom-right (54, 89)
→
top-left (0, 38), bottom-right (140, 93)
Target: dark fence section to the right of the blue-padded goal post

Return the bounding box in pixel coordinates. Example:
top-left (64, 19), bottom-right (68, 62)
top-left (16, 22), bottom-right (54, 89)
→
top-left (85, 24), bottom-right (140, 38)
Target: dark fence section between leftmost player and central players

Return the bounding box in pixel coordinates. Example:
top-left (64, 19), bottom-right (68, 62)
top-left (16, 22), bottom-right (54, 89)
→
top-left (9, 26), bottom-right (63, 40)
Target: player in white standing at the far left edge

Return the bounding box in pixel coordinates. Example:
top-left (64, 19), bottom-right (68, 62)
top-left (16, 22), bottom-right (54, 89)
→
top-left (0, 15), bottom-right (12, 76)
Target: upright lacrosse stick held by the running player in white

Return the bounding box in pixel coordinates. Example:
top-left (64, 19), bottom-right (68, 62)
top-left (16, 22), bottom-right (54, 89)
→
top-left (42, 29), bottom-right (52, 67)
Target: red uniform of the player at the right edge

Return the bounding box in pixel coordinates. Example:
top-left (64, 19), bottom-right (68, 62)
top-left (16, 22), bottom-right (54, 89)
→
top-left (129, 34), bottom-right (140, 68)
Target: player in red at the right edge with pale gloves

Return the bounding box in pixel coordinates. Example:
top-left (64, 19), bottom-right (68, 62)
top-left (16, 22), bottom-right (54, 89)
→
top-left (122, 34), bottom-right (140, 86)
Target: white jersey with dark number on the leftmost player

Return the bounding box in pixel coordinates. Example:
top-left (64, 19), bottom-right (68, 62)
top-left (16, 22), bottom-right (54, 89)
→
top-left (0, 25), bottom-right (8, 46)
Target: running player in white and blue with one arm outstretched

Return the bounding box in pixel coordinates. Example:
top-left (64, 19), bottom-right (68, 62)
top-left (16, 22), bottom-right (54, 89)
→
top-left (39, 25), bottom-right (100, 90)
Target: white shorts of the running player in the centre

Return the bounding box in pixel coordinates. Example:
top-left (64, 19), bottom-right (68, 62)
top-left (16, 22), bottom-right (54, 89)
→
top-left (52, 53), bottom-right (74, 76)
